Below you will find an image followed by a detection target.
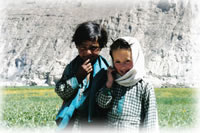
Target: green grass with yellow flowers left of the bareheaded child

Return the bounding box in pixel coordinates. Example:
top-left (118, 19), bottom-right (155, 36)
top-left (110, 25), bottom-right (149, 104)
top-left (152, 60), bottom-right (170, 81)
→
top-left (2, 87), bottom-right (62, 127)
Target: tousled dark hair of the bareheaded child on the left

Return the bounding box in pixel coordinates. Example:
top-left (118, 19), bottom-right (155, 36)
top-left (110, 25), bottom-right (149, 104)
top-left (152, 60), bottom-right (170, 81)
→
top-left (72, 21), bottom-right (108, 48)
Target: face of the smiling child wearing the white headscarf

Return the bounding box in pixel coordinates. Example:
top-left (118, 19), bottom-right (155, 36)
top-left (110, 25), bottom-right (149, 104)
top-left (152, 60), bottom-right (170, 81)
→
top-left (112, 49), bottom-right (133, 76)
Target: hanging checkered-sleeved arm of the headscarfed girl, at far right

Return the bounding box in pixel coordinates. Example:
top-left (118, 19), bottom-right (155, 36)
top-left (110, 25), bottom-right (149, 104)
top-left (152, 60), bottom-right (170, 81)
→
top-left (143, 84), bottom-right (158, 131)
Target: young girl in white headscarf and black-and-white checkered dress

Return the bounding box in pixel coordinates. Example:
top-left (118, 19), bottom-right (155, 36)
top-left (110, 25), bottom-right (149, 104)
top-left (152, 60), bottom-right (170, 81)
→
top-left (96, 37), bottom-right (158, 131)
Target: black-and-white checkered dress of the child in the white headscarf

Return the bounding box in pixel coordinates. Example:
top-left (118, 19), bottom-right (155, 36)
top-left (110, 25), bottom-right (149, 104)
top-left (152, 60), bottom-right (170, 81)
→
top-left (97, 80), bottom-right (158, 131)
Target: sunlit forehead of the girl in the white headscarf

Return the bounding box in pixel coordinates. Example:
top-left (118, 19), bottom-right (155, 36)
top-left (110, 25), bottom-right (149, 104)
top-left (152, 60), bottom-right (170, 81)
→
top-left (112, 49), bottom-right (132, 61)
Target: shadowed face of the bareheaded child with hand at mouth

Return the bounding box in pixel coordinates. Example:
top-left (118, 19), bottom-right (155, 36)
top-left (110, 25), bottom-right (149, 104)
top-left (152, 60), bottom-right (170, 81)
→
top-left (77, 41), bottom-right (101, 62)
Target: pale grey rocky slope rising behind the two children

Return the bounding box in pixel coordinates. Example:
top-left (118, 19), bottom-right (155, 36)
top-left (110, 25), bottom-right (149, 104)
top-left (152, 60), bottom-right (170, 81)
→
top-left (0, 0), bottom-right (200, 87)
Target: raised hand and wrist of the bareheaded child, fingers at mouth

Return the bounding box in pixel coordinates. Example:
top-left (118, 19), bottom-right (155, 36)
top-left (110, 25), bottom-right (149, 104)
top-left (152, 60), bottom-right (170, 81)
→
top-left (76, 59), bottom-right (93, 83)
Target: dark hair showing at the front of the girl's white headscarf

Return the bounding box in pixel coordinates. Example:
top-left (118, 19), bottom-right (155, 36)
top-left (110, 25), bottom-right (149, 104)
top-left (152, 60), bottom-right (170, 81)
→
top-left (110, 38), bottom-right (131, 59)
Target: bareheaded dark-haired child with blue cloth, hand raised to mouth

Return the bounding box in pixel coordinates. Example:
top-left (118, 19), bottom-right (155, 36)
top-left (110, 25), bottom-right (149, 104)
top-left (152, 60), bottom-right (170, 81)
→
top-left (55, 21), bottom-right (108, 129)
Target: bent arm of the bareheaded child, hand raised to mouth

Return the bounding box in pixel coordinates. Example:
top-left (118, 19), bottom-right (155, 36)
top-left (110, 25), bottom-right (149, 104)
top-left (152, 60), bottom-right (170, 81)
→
top-left (55, 59), bottom-right (93, 100)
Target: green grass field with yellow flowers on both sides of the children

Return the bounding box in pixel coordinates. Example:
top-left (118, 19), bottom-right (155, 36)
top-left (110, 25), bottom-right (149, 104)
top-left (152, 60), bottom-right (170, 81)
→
top-left (2, 87), bottom-right (197, 128)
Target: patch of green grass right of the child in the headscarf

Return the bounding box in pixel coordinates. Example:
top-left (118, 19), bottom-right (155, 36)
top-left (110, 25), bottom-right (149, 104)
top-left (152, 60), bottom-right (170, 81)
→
top-left (155, 88), bottom-right (197, 128)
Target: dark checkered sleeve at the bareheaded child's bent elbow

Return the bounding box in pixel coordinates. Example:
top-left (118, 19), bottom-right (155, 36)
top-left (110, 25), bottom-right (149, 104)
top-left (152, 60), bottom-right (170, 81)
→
top-left (55, 80), bottom-right (76, 100)
